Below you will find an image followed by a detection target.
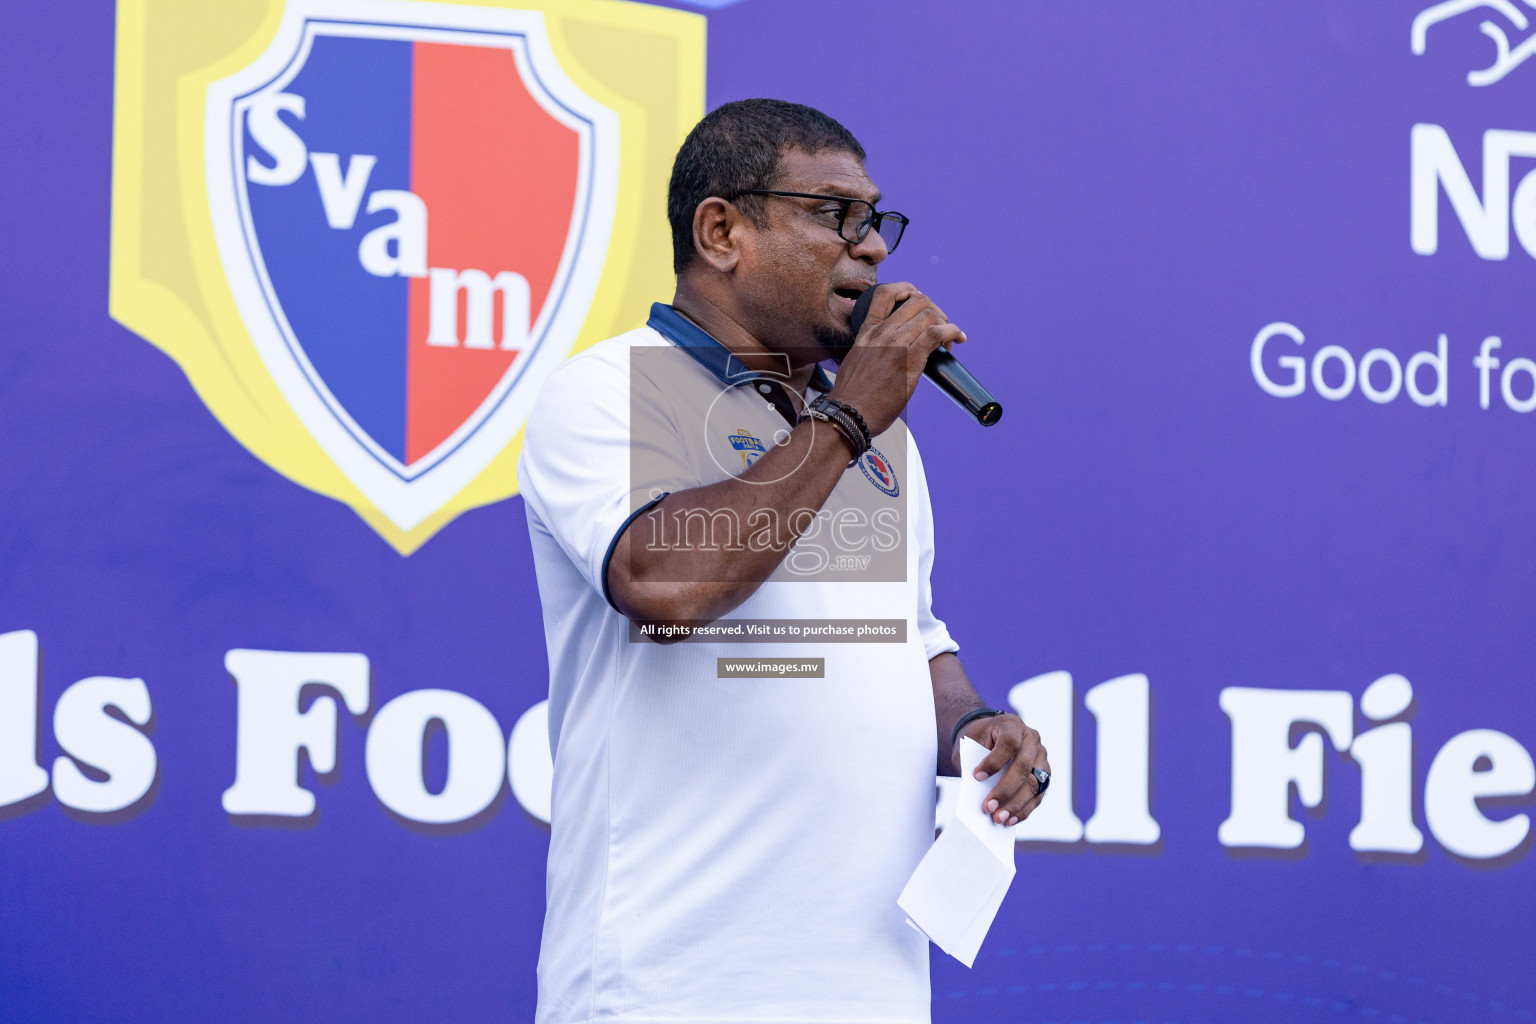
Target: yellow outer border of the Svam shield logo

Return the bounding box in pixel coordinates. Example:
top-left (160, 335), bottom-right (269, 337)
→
top-left (109, 0), bottom-right (705, 554)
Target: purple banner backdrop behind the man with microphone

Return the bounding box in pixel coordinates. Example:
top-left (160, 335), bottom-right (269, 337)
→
top-left (0, 0), bottom-right (1536, 1022)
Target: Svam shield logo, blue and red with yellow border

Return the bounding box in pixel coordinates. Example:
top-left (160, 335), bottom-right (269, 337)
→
top-left (114, 0), bottom-right (702, 553)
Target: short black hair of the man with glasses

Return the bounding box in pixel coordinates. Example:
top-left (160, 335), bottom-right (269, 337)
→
top-left (667, 100), bottom-right (865, 273)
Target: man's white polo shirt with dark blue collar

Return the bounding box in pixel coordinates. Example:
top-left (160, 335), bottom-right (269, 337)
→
top-left (518, 304), bottom-right (957, 1024)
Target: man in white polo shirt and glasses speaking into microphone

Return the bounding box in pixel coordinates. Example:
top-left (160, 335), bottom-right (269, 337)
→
top-left (518, 100), bottom-right (1049, 1024)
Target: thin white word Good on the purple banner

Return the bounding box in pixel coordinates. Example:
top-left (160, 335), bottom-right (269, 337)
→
top-left (1249, 321), bottom-right (1449, 408)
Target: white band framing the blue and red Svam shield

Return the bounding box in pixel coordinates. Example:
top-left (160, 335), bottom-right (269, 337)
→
top-left (203, 0), bottom-right (619, 530)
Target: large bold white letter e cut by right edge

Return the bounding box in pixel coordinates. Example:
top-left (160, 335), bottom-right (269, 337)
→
top-left (1424, 729), bottom-right (1536, 860)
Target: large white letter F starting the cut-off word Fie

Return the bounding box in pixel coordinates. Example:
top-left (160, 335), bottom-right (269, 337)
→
top-left (1217, 686), bottom-right (1355, 849)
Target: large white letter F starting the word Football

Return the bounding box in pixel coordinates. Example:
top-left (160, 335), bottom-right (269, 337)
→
top-left (223, 648), bottom-right (372, 818)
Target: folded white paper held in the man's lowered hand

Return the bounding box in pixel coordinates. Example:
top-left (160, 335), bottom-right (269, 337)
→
top-left (895, 737), bottom-right (1014, 967)
